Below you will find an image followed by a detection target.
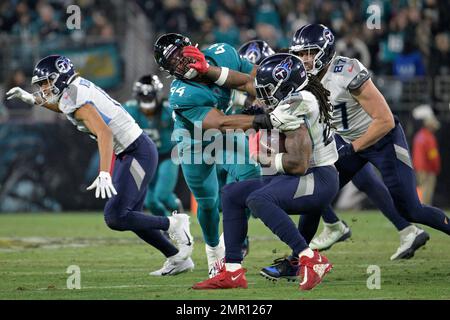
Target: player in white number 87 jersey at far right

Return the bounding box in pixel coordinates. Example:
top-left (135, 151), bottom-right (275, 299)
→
top-left (290, 24), bottom-right (450, 260)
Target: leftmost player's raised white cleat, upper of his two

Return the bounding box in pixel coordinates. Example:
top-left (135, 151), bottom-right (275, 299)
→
top-left (167, 211), bottom-right (194, 259)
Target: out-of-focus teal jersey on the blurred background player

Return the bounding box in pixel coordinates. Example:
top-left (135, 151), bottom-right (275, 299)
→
top-left (124, 100), bottom-right (175, 154)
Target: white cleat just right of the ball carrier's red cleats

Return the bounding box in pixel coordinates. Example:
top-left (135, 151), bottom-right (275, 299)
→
top-left (309, 221), bottom-right (352, 250)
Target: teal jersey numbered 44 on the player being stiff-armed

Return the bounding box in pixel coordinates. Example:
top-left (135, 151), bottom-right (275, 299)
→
top-left (169, 43), bottom-right (253, 146)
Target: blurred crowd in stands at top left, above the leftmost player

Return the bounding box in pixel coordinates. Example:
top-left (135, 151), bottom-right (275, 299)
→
top-left (0, 0), bottom-right (119, 120)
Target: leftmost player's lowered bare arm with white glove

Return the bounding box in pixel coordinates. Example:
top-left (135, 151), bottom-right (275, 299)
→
top-left (75, 103), bottom-right (117, 199)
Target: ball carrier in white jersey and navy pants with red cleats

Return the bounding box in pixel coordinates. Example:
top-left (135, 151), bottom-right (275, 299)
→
top-left (193, 53), bottom-right (339, 290)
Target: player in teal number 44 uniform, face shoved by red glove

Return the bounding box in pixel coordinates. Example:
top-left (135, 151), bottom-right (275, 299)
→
top-left (154, 33), bottom-right (298, 276)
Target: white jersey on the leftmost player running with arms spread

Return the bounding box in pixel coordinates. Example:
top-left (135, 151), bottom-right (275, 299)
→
top-left (59, 77), bottom-right (142, 154)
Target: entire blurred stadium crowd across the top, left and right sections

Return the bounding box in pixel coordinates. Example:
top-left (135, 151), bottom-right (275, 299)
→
top-left (0, 0), bottom-right (450, 119)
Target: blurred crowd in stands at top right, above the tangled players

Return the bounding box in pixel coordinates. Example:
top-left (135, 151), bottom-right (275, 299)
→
top-left (140, 0), bottom-right (450, 77)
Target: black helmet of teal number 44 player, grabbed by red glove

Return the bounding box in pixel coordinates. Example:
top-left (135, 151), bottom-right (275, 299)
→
top-left (154, 33), bottom-right (195, 79)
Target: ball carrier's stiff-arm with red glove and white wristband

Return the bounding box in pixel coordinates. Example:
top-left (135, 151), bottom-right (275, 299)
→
top-left (183, 46), bottom-right (256, 96)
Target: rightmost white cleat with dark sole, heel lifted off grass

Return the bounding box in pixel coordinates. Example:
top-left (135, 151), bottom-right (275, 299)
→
top-left (391, 225), bottom-right (430, 260)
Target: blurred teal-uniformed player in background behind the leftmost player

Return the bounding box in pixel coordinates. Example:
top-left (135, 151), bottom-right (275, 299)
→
top-left (124, 74), bottom-right (183, 216)
